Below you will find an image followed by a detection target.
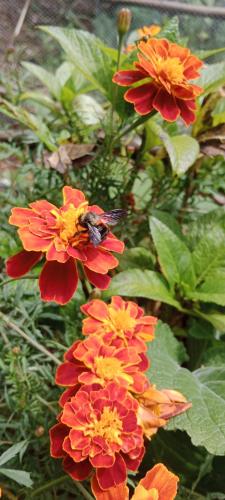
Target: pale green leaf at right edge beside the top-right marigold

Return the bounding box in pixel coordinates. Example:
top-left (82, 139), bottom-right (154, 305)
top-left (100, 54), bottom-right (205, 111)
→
top-left (195, 61), bottom-right (225, 95)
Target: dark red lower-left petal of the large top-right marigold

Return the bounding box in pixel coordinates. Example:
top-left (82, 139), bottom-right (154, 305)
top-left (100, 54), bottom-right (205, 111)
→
top-left (124, 83), bottom-right (157, 115)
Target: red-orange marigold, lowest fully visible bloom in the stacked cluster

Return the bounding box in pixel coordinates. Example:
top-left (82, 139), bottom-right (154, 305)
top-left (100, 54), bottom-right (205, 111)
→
top-left (50, 382), bottom-right (144, 490)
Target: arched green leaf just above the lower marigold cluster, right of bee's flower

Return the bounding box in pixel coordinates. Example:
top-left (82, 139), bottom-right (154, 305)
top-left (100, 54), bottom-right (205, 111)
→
top-left (104, 269), bottom-right (180, 309)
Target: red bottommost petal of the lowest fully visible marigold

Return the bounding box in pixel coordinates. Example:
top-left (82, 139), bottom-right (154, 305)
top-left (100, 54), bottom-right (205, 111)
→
top-left (96, 454), bottom-right (127, 490)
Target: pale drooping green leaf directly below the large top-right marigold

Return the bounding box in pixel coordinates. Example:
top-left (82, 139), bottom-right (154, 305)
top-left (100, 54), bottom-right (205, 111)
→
top-left (148, 120), bottom-right (199, 176)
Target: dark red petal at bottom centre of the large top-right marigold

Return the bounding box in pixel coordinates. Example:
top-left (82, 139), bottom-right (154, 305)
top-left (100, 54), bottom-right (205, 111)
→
top-left (153, 89), bottom-right (180, 122)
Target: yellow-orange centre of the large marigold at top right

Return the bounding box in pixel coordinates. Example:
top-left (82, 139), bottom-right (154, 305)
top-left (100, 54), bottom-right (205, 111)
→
top-left (155, 57), bottom-right (184, 85)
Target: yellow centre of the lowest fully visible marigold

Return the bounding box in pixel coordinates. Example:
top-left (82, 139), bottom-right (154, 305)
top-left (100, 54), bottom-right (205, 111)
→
top-left (84, 406), bottom-right (122, 445)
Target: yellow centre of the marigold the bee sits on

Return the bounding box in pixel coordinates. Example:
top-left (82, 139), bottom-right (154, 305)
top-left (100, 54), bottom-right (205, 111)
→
top-left (51, 201), bottom-right (88, 246)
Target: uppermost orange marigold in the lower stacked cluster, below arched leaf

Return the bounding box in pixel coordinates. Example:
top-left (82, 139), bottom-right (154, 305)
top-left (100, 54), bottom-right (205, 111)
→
top-left (81, 296), bottom-right (157, 352)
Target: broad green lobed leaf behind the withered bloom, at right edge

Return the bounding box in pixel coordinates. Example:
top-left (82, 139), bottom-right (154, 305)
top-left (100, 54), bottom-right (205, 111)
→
top-left (148, 322), bottom-right (225, 455)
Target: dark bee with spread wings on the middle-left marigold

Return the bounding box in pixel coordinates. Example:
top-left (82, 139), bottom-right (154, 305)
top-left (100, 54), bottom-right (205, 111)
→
top-left (79, 208), bottom-right (127, 247)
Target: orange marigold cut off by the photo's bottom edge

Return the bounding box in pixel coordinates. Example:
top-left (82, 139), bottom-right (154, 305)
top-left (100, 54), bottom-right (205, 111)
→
top-left (91, 464), bottom-right (179, 500)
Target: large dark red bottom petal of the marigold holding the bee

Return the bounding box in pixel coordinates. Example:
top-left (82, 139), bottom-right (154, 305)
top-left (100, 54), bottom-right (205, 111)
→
top-left (39, 259), bottom-right (78, 305)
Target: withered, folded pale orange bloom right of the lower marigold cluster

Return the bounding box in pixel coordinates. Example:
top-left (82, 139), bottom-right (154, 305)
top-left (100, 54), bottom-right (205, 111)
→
top-left (137, 385), bottom-right (192, 439)
